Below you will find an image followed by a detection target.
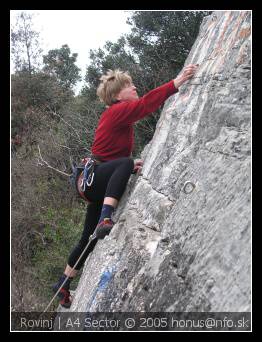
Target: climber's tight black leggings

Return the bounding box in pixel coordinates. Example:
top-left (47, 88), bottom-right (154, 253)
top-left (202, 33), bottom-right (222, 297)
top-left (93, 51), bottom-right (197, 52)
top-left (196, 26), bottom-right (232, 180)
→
top-left (68, 157), bottom-right (134, 270)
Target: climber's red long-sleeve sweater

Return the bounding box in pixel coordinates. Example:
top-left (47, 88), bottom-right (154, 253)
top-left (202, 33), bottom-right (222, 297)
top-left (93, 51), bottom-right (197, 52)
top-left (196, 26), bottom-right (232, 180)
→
top-left (91, 81), bottom-right (178, 161)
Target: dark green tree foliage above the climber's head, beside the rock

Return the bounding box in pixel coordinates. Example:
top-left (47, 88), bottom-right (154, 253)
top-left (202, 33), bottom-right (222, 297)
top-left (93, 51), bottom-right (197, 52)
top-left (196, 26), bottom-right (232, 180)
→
top-left (85, 11), bottom-right (208, 94)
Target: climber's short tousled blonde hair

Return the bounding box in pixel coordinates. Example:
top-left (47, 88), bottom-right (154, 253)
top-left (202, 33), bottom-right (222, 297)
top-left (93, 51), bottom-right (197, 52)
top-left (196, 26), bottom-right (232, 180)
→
top-left (96, 69), bottom-right (132, 106)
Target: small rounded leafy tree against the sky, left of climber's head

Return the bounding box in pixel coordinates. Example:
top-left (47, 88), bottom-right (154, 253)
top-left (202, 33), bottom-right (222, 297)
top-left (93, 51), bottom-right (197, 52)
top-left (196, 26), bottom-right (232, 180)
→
top-left (43, 44), bottom-right (81, 89)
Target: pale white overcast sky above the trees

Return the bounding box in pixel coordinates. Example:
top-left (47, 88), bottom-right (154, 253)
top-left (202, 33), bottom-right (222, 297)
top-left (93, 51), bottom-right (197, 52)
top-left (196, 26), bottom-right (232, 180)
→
top-left (10, 10), bottom-right (134, 93)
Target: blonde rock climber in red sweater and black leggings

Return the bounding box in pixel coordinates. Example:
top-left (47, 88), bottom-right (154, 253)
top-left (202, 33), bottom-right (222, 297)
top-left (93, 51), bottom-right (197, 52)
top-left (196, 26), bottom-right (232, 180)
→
top-left (53, 64), bottom-right (198, 308)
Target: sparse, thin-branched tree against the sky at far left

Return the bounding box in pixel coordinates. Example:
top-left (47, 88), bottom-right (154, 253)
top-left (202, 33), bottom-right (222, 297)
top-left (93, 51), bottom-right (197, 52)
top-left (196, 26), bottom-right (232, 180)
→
top-left (11, 12), bottom-right (42, 74)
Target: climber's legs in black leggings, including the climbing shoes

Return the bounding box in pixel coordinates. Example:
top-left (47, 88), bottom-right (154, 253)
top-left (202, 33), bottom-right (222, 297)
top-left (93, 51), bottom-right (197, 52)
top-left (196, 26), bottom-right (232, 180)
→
top-left (53, 158), bottom-right (134, 305)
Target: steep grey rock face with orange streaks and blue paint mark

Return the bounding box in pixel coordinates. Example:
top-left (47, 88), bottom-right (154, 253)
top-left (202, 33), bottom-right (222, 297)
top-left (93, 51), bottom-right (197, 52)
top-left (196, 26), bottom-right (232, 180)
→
top-left (71, 11), bottom-right (251, 312)
